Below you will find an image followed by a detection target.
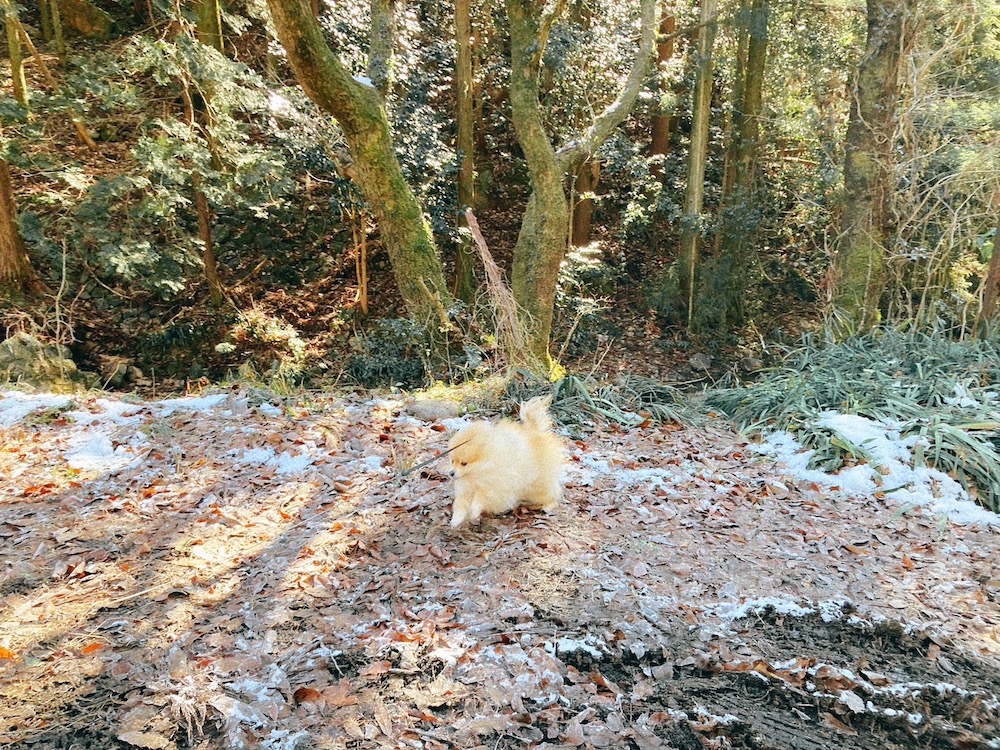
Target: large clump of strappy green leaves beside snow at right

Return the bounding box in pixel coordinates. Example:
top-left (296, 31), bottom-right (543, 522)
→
top-left (706, 329), bottom-right (1000, 510)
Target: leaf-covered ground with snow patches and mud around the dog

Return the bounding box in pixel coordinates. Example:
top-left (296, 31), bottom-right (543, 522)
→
top-left (0, 387), bottom-right (1000, 750)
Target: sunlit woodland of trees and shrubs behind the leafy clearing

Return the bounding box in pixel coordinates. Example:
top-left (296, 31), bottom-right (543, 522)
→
top-left (0, 0), bottom-right (1000, 438)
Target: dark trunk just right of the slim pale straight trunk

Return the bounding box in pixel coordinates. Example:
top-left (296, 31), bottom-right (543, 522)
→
top-left (695, 0), bottom-right (770, 335)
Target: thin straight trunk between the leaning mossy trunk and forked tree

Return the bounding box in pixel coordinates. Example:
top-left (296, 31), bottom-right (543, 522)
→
top-left (455, 0), bottom-right (476, 303)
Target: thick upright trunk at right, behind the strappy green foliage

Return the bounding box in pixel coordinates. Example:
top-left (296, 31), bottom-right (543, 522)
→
top-left (833, 0), bottom-right (911, 332)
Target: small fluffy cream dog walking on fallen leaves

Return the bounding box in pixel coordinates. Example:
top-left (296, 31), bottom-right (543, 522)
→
top-left (448, 397), bottom-right (566, 526)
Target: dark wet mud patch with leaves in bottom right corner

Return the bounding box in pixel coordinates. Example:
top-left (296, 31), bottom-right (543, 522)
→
top-left (557, 610), bottom-right (1000, 750)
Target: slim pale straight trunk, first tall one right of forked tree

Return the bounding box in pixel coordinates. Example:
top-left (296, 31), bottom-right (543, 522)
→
top-left (677, 0), bottom-right (716, 327)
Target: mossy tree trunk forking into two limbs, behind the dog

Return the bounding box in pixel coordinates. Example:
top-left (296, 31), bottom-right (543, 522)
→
top-left (506, 0), bottom-right (656, 372)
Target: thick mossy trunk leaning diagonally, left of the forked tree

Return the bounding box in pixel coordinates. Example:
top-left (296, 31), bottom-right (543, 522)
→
top-left (268, 0), bottom-right (451, 324)
